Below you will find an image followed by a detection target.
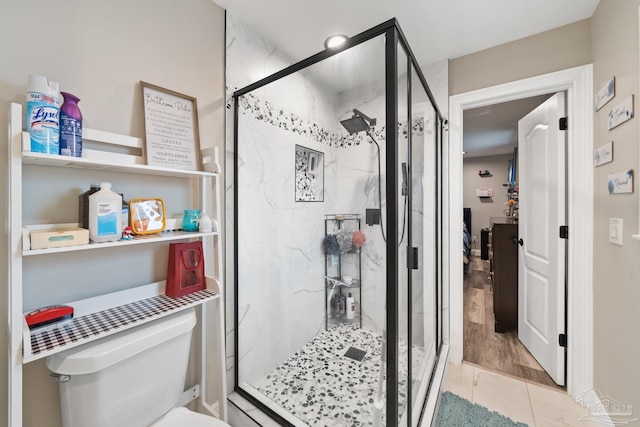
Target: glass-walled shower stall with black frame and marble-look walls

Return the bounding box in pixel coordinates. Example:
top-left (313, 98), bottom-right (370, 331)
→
top-left (233, 20), bottom-right (446, 427)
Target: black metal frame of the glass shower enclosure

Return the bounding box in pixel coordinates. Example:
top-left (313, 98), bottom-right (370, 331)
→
top-left (232, 18), bottom-right (446, 427)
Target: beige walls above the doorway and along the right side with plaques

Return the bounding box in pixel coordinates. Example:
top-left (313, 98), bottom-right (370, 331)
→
top-left (449, 0), bottom-right (640, 418)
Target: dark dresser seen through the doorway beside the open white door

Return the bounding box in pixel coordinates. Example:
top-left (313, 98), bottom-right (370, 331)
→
top-left (490, 217), bottom-right (518, 332)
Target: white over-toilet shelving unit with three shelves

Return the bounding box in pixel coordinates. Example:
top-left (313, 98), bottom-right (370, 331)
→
top-left (7, 103), bottom-right (227, 426)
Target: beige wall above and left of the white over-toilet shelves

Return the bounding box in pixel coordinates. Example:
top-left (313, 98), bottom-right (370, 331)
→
top-left (0, 0), bottom-right (225, 427)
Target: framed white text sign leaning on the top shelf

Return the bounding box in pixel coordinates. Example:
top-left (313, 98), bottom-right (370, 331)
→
top-left (140, 82), bottom-right (201, 170)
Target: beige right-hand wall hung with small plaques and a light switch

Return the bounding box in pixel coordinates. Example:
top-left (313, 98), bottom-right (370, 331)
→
top-left (591, 0), bottom-right (640, 418)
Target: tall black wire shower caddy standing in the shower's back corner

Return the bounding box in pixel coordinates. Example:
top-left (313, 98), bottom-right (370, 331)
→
top-left (324, 214), bottom-right (362, 330)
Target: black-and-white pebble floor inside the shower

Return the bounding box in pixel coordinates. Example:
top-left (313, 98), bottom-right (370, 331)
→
top-left (255, 325), bottom-right (424, 427)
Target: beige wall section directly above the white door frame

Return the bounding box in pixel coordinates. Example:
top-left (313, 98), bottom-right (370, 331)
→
top-left (449, 19), bottom-right (592, 95)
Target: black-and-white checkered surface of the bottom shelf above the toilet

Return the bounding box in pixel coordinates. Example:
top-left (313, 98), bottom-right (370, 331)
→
top-left (25, 289), bottom-right (218, 358)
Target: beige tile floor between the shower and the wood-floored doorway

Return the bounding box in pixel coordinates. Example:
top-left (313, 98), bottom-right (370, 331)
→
top-left (443, 363), bottom-right (598, 427)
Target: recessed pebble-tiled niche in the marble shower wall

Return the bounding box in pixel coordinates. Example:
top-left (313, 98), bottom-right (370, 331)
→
top-left (295, 145), bottom-right (324, 202)
